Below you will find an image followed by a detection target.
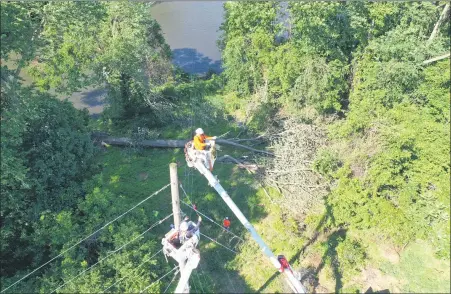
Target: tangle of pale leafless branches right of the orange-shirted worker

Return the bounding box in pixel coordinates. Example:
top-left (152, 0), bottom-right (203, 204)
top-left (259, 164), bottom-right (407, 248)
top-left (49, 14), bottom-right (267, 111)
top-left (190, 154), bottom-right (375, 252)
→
top-left (261, 120), bottom-right (327, 219)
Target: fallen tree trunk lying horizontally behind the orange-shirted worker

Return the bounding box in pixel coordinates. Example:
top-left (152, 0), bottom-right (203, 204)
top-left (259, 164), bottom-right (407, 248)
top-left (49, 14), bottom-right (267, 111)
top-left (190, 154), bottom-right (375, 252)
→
top-left (100, 137), bottom-right (274, 156)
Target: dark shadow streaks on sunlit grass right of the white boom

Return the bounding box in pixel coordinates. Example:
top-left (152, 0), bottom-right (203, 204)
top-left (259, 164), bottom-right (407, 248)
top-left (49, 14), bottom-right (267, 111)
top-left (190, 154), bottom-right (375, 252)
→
top-left (257, 202), bottom-right (335, 293)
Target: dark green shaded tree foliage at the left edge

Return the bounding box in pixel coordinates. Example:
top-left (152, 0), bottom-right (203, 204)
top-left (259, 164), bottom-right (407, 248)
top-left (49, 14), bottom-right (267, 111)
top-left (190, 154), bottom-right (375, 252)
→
top-left (1, 89), bottom-right (95, 275)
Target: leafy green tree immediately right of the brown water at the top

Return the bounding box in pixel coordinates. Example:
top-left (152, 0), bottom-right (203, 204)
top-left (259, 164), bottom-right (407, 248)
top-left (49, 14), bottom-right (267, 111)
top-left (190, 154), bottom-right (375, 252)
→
top-left (219, 2), bottom-right (280, 96)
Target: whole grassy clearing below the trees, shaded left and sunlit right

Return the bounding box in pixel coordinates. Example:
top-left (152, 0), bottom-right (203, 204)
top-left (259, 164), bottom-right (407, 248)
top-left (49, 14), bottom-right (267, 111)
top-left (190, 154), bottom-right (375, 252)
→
top-left (90, 90), bottom-right (450, 293)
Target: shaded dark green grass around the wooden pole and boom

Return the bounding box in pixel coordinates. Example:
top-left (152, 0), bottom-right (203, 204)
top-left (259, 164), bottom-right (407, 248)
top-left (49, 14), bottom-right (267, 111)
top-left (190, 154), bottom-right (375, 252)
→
top-left (91, 126), bottom-right (272, 292)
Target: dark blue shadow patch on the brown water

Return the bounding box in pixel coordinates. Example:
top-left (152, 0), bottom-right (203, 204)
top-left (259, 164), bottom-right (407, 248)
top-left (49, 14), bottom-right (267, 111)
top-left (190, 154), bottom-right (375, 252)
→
top-left (172, 48), bottom-right (222, 74)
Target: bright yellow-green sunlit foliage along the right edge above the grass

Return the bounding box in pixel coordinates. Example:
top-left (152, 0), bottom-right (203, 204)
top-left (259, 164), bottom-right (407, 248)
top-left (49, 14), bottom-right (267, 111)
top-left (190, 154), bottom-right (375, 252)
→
top-left (322, 4), bottom-right (450, 256)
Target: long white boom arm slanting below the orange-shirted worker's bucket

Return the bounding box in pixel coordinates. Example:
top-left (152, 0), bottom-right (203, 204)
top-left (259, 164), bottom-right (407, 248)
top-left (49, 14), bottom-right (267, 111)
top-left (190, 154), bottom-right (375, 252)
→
top-left (194, 160), bottom-right (307, 293)
